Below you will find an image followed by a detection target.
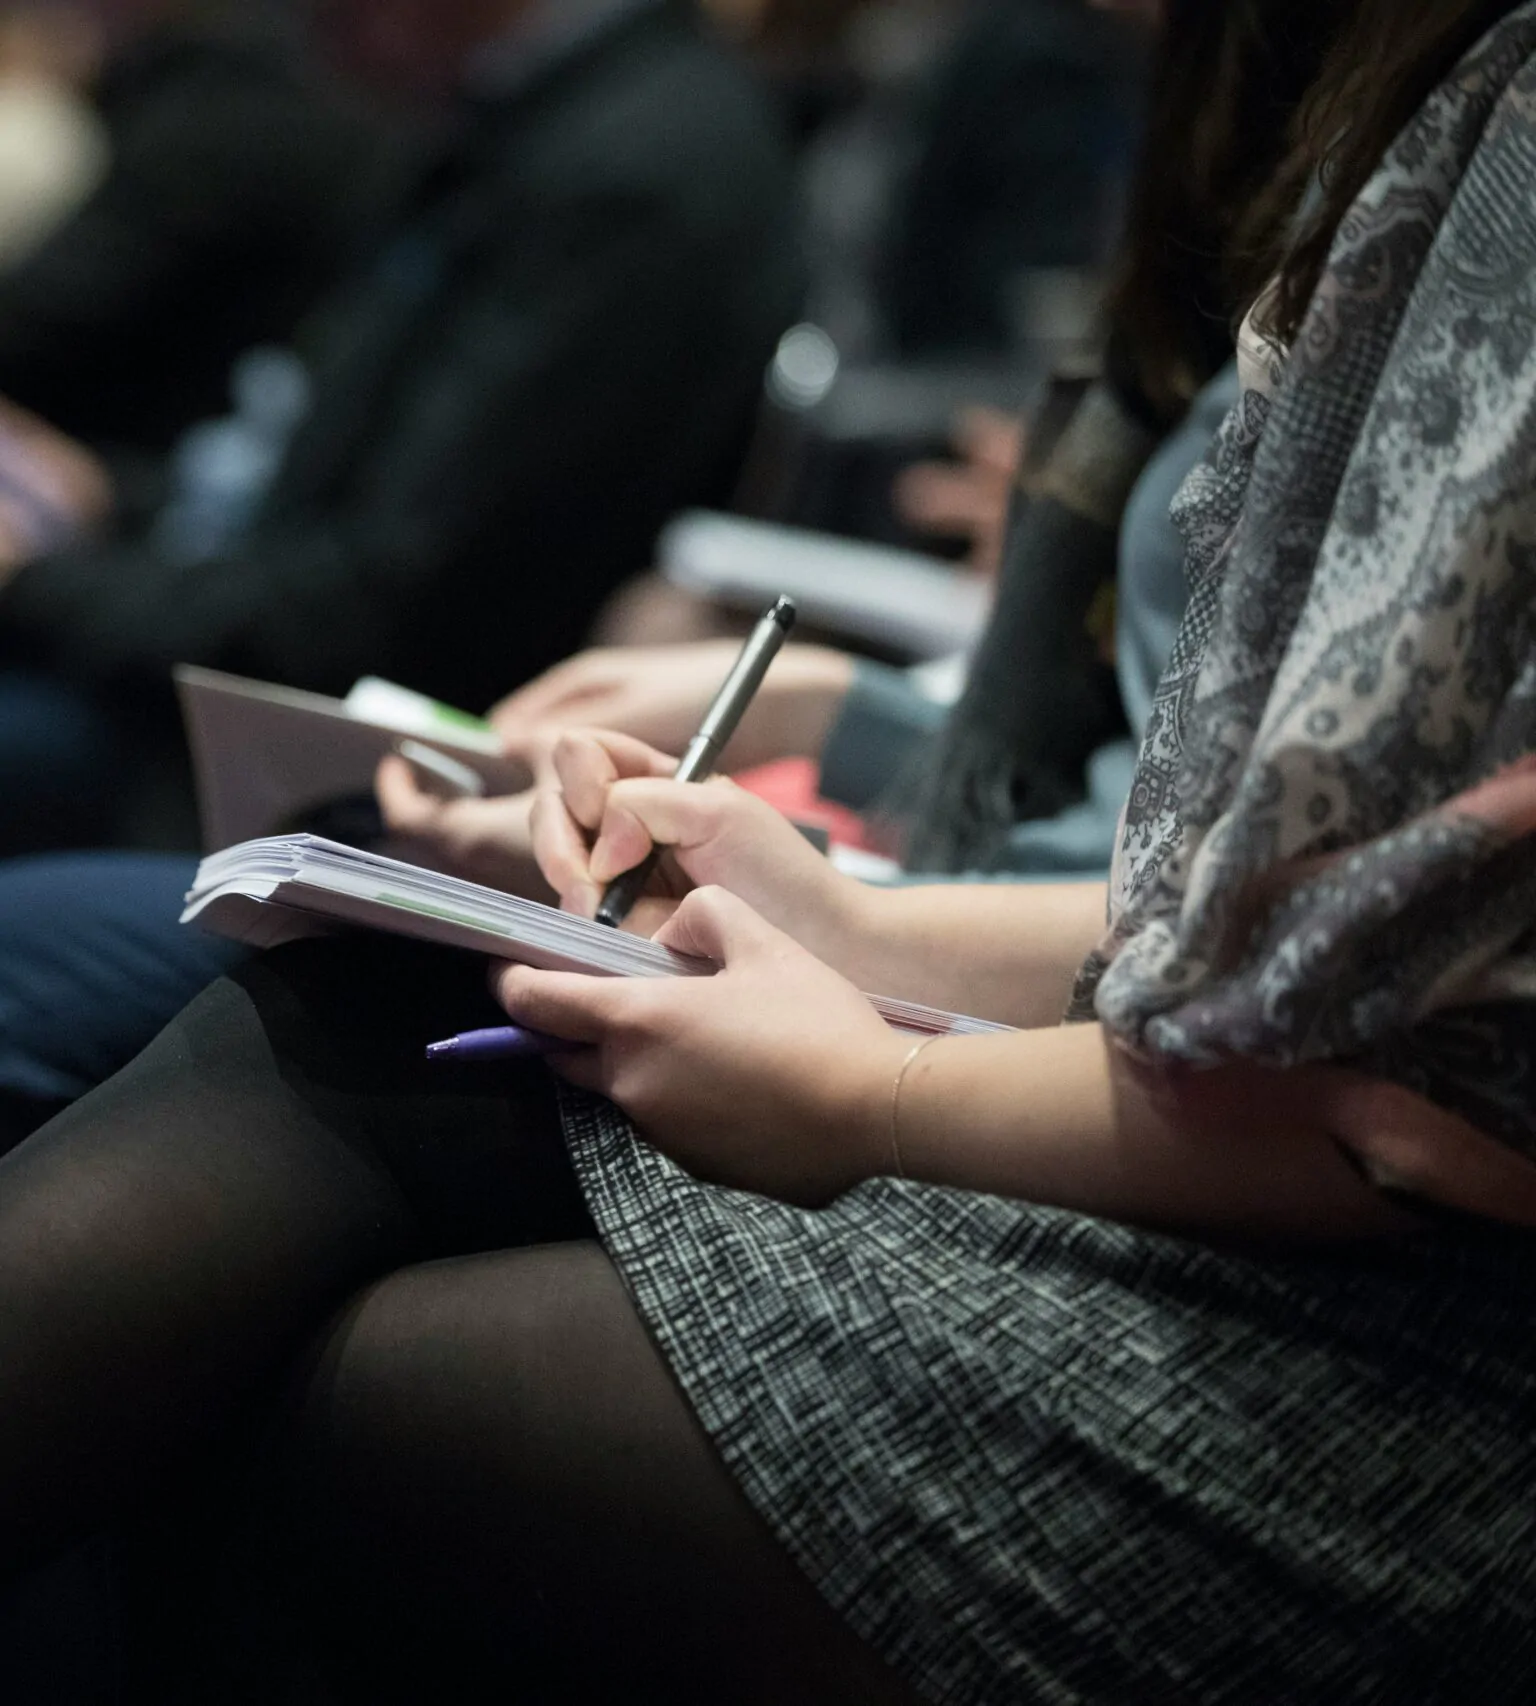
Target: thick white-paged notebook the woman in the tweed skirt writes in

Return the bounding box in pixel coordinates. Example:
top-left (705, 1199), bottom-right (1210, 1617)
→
top-left (181, 836), bottom-right (1007, 1036)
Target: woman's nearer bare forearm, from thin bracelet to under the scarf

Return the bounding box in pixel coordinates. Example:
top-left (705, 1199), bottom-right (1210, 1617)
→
top-left (893, 1025), bottom-right (1411, 1240)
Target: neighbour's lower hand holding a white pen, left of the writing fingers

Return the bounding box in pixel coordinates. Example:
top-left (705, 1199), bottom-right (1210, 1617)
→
top-left (374, 756), bottom-right (555, 901)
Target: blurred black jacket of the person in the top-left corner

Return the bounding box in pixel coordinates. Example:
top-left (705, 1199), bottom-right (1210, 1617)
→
top-left (0, 7), bottom-right (398, 454)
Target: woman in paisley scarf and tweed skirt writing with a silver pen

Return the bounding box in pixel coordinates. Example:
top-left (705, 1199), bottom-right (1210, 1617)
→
top-left (0, 0), bottom-right (1536, 1706)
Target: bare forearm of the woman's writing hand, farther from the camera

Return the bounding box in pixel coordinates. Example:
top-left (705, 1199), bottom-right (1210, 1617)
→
top-left (832, 882), bottom-right (1104, 1027)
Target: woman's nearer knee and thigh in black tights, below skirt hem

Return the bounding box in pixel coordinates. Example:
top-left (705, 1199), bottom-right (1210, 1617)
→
top-left (257, 1244), bottom-right (911, 1706)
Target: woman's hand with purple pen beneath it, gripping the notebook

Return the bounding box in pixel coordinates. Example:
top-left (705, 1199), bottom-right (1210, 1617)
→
top-left (493, 889), bottom-right (911, 1206)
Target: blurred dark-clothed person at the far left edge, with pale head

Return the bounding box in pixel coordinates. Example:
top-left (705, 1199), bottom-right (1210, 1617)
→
top-left (0, 0), bottom-right (398, 859)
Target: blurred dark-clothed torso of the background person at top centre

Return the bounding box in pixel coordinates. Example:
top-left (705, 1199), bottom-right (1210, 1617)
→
top-left (708, 0), bottom-right (1143, 360)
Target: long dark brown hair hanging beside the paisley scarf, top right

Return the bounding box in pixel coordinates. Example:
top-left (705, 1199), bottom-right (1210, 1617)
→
top-left (1109, 0), bottom-right (1521, 420)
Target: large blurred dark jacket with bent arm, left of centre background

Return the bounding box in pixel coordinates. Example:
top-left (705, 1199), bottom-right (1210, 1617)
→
top-left (0, 7), bottom-right (799, 706)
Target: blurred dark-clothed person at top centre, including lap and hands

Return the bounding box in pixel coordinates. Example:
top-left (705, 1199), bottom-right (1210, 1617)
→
top-left (594, 0), bottom-right (1147, 645)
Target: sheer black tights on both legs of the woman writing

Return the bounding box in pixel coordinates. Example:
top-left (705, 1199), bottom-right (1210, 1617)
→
top-left (0, 942), bottom-right (911, 1703)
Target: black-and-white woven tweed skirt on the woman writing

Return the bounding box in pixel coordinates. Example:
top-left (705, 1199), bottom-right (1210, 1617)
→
top-left (563, 1094), bottom-right (1536, 1706)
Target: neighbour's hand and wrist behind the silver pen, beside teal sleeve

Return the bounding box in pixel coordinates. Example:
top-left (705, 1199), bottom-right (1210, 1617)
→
top-left (492, 640), bottom-right (853, 769)
